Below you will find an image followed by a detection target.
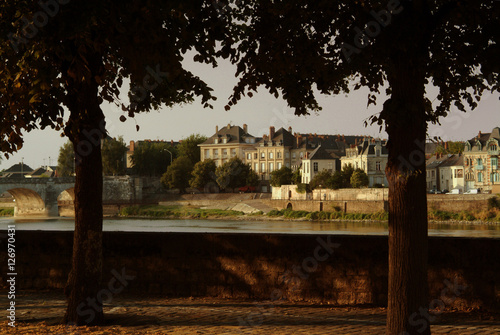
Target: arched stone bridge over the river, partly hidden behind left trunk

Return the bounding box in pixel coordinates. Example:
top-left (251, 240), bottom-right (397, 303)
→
top-left (0, 176), bottom-right (142, 217)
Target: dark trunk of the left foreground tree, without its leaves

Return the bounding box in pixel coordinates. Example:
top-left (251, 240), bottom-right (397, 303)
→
top-left (63, 51), bottom-right (105, 325)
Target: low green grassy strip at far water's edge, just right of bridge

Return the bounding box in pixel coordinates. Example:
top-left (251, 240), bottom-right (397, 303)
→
top-left (120, 205), bottom-right (244, 219)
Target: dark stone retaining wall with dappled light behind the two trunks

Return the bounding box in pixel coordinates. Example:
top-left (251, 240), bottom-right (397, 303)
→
top-left (0, 231), bottom-right (500, 309)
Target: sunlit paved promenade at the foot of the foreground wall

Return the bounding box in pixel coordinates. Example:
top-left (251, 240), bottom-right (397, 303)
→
top-left (0, 291), bottom-right (500, 335)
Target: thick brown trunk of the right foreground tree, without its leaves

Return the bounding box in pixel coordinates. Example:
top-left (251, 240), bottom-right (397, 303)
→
top-left (383, 59), bottom-right (430, 335)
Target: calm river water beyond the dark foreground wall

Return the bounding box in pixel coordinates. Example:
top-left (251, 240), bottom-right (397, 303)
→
top-left (0, 218), bottom-right (500, 238)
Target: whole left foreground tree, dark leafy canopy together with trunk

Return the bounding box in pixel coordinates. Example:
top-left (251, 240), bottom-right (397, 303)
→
top-left (0, 0), bottom-right (234, 325)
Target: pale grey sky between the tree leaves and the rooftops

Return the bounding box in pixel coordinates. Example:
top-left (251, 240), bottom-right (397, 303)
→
top-left (0, 56), bottom-right (500, 170)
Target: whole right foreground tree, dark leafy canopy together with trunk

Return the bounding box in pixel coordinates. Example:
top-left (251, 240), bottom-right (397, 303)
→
top-left (226, 0), bottom-right (500, 334)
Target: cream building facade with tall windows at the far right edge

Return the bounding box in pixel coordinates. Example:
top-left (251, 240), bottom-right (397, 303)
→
top-left (464, 127), bottom-right (500, 192)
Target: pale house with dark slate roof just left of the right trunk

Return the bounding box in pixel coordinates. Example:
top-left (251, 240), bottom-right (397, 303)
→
top-left (340, 138), bottom-right (389, 187)
